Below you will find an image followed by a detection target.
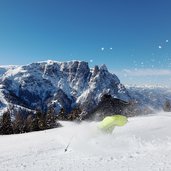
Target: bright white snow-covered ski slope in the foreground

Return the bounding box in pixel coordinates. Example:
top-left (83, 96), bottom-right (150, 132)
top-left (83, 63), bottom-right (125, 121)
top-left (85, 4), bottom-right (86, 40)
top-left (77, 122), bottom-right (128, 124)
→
top-left (0, 113), bottom-right (171, 171)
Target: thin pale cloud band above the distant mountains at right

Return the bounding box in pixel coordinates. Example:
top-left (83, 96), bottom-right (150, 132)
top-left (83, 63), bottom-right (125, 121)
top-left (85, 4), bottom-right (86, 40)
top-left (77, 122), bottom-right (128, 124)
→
top-left (123, 69), bottom-right (171, 77)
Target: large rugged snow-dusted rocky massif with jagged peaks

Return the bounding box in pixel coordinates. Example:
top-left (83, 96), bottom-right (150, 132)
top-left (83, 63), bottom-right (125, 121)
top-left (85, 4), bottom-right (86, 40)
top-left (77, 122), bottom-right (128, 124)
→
top-left (0, 61), bottom-right (130, 116)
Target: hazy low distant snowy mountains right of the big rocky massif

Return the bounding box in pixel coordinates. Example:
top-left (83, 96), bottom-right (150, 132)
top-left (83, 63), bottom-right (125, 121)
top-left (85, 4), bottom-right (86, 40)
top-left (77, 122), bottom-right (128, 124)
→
top-left (126, 86), bottom-right (171, 115)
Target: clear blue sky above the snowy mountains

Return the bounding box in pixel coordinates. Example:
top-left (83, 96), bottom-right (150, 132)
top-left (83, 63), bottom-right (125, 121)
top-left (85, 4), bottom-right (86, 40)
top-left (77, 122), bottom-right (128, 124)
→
top-left (0, 0), bottom-right (171, 85)
